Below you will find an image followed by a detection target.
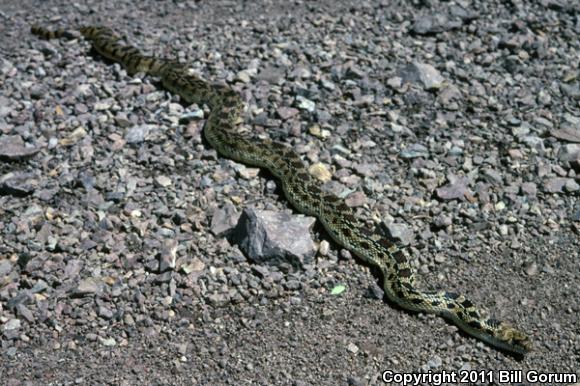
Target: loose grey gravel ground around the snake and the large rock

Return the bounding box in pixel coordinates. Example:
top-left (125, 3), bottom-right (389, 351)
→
top-left (0, 0), bottom-right (580, 386)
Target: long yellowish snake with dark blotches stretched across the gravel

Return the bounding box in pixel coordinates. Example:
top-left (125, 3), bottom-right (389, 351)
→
top-left (31, 25), bottom-right (533, 356)
